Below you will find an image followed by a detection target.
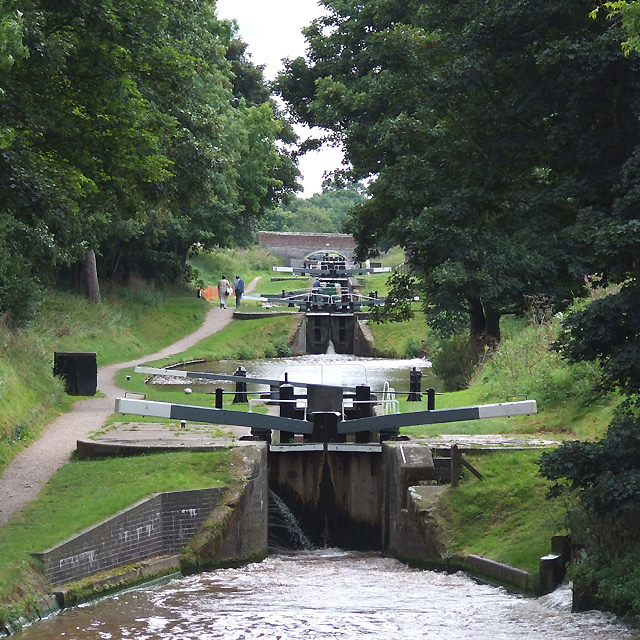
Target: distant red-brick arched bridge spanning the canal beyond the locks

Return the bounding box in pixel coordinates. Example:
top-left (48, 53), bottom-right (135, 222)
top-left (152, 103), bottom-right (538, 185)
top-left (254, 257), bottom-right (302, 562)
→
top-left (258, 231), bottom-right (356, 267)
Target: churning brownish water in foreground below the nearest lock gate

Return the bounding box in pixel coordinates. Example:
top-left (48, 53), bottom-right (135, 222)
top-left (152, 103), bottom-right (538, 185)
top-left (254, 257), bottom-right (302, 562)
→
top-left (17, 549), bottom-right (640, 640)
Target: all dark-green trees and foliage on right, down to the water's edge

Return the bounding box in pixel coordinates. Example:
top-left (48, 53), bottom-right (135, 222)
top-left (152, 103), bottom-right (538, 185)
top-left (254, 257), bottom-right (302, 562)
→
top-left (278, 0), bottom-right (640, 615)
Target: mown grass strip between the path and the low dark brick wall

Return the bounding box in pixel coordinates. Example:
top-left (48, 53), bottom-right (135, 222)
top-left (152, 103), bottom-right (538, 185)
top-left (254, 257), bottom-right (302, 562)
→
top-left (0, 451), bottom-right (233, 620)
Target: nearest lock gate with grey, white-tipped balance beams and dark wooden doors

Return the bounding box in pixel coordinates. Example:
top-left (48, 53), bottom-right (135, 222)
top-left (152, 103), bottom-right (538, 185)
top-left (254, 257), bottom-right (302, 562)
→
top-left (115, 367), bottom-right (537, 560)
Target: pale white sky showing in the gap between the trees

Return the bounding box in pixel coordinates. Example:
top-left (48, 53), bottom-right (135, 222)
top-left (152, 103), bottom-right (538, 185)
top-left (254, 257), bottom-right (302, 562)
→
top-left (216, 0), bottom-right (342, 198)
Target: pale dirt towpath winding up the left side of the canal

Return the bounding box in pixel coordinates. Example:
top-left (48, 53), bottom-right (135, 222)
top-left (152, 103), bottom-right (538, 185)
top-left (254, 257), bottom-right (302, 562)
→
top-left (0, 278), bottom-right (259, 525)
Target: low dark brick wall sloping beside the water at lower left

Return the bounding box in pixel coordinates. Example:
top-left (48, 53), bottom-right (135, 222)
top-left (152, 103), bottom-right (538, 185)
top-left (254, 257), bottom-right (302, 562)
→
top-left (33, 488), bottom-right (221, 586)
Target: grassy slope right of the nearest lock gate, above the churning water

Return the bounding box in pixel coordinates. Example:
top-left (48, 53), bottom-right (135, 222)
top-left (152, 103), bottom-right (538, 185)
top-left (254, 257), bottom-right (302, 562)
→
top-left (441, 451), bottom-right (565, 574)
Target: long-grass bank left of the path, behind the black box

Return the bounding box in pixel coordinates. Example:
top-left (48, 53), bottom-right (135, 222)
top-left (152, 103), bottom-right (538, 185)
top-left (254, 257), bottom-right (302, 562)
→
top-left (0, 283), bottom-right (208, 472)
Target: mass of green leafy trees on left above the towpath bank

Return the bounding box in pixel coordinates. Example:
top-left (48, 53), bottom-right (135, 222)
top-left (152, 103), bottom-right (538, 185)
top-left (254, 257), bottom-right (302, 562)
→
top-left (0, 0), bottom-right (298, 321)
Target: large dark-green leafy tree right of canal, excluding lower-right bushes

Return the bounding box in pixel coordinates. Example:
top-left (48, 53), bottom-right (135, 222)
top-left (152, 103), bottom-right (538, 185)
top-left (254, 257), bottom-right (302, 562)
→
top-left (279, 0), bottom-right (640, 350)
